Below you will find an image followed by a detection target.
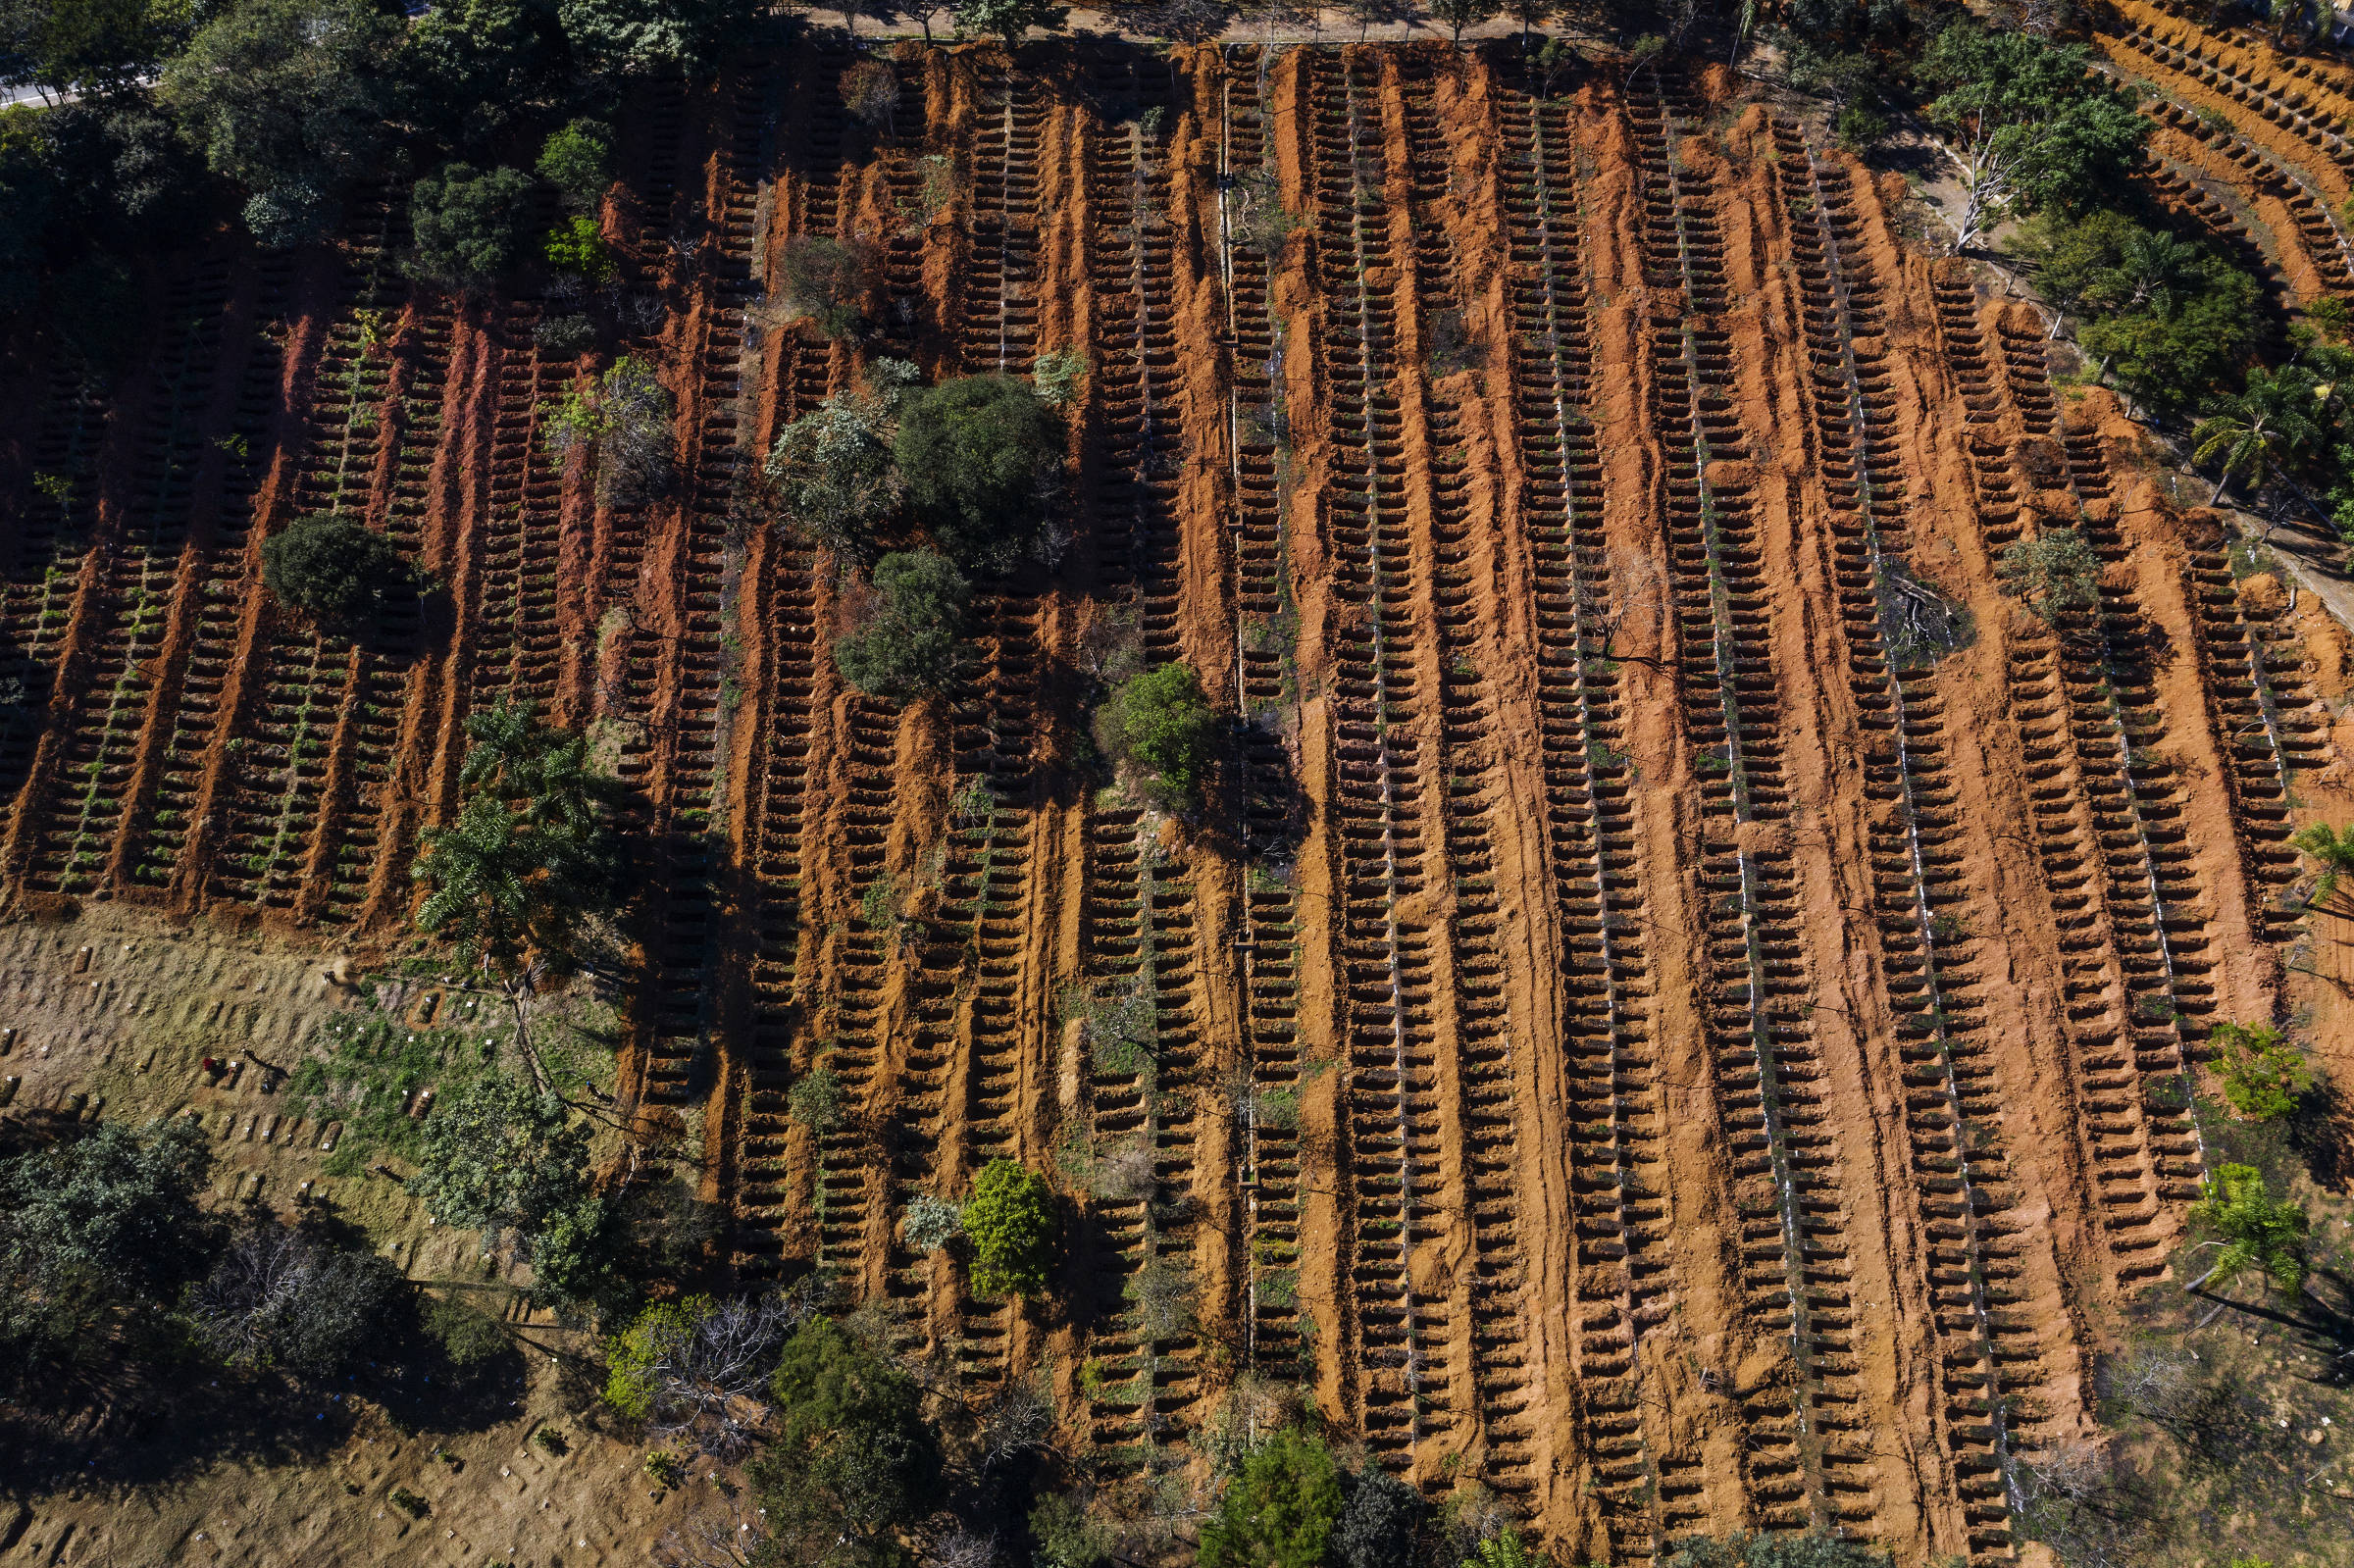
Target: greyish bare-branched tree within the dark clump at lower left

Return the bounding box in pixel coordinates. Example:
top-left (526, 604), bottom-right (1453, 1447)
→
top-left (188, 1217), bottom-right (402, 1378)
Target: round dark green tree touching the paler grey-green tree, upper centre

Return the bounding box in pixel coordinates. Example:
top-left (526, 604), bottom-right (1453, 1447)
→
top-left (893, 377), bottom-right (1064, 572)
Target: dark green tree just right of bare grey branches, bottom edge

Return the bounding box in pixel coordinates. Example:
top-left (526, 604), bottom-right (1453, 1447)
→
top-left (746, 1316), bottom-right (942, 1568)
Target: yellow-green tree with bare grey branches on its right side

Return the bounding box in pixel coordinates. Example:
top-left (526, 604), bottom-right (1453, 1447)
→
top-left (605, 1294), bottom-right (807, 1457)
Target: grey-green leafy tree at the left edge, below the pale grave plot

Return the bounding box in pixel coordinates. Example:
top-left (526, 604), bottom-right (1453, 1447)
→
top-left (0, 1116), bottom-right (212, 1373)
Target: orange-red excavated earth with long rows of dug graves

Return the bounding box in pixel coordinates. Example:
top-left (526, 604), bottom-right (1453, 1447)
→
top-left (0, 30), bottom-right (2354, 1563)
